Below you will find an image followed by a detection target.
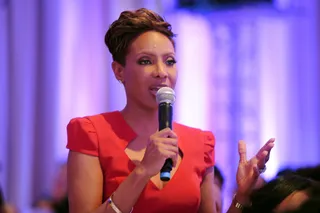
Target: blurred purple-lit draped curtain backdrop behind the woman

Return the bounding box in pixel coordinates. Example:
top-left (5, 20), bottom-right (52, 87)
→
top-left (0, 0), bottom-right (320, 212)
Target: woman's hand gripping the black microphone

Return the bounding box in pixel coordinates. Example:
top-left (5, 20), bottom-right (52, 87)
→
top-left (141, 128), bottom-right (179, 177)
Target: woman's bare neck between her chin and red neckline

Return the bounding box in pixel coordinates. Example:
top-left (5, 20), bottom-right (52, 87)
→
top-left (121, 105), bottom-right (159, 137)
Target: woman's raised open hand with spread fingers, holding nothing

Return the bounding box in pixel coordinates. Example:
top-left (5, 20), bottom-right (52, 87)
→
top-left (237, 138), bottom-right (275, 201)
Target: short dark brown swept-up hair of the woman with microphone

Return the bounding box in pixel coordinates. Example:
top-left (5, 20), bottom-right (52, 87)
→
top-left (104, 8), bottom-right (175, 66)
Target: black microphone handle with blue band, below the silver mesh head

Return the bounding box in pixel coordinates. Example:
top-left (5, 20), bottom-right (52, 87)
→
top-left (158, 102), bottom-right (173, 181)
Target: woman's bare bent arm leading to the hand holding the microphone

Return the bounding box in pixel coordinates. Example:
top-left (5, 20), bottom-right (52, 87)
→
top-left (68, 151), bottom-right (149, 213)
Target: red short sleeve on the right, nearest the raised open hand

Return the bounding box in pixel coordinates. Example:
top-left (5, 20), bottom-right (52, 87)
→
top-left (202, 131), bottom-right (215, 169)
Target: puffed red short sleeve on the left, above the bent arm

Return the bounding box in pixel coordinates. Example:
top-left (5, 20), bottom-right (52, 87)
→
top-left (67, 118), bottom-right (99, 156)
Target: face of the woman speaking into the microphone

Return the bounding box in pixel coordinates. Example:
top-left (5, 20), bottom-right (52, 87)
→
top-left (116, 31), bottom-right (177, 109)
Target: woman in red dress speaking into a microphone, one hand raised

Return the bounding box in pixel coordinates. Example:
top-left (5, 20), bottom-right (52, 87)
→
top-left (67, 9), bottom-right (274, 213)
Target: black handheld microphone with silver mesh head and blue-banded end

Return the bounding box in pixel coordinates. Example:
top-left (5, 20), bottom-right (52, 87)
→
top-left (156, 87), bottom-right (176, 181)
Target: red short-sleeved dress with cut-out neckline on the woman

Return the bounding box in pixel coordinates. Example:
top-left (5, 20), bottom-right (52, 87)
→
top-left (67, 111), bottom-right (214, 213)
